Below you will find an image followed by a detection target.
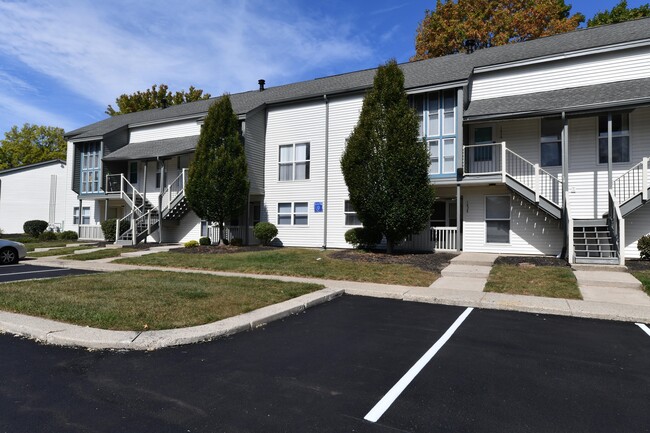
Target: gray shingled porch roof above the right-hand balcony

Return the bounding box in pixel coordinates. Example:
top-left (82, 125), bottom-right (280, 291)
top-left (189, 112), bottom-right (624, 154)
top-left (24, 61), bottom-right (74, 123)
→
top-left (464, 78), bottom-right (650, 122)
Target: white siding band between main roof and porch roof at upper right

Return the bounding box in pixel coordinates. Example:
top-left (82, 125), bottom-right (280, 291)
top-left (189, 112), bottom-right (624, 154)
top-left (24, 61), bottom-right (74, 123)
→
top-left (471, 46), bottom-right (650, 101)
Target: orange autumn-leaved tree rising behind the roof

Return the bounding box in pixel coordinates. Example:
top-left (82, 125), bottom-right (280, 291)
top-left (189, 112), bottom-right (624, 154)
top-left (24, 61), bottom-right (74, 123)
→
top-left (411, 0), bottom-right (585, 60)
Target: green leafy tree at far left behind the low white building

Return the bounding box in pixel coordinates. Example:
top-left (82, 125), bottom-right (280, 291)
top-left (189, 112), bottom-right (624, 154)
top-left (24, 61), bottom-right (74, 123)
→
top-left (0, 123), bottom-right (66, 170)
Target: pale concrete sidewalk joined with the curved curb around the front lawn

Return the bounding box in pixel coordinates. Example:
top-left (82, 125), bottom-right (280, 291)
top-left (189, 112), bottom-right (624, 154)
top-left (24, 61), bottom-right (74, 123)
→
top-left (0, 256), bottom-right (650, 350)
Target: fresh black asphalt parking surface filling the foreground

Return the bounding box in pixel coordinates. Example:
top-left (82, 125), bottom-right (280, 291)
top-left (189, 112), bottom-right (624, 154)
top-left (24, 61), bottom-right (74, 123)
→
top-left (0, 296), bottom-right (650, 432)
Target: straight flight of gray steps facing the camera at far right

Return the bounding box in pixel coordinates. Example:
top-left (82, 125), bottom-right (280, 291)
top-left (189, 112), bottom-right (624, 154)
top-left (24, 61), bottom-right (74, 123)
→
top-left (573, 219), bottom-right (619, 265)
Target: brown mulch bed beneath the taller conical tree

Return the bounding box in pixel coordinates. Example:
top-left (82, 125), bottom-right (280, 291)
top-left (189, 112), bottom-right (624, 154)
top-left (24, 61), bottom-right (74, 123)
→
top-left (330, 250), bottom-right (458, 273)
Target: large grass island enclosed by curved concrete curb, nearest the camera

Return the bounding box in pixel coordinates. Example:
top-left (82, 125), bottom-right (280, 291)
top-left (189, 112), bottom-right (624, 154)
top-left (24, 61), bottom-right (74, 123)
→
top-left (0, 271), bottom-right (322, 330)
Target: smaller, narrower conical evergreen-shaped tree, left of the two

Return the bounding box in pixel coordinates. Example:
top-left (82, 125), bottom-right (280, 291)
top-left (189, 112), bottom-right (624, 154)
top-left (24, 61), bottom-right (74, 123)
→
top-left (185, 94), bottom-right (249, 243)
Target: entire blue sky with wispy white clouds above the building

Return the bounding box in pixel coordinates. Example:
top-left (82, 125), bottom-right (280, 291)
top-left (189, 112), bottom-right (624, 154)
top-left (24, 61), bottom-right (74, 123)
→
top-left (0, 0), bottom-right (648, 138)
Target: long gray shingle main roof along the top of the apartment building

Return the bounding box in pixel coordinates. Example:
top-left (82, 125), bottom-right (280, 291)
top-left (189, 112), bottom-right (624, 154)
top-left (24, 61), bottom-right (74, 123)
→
top-left (66, 18), bottom-right (650, 139)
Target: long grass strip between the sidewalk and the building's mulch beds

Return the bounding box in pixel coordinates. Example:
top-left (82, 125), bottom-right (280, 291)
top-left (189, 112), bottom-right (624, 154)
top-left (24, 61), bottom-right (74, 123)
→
top-left (116, 248), bottom-right (439, 287)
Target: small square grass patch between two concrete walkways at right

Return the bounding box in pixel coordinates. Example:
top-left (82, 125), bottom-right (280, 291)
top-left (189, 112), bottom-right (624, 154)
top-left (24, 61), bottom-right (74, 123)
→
top-left (485, 265), bottom-right (582, 299)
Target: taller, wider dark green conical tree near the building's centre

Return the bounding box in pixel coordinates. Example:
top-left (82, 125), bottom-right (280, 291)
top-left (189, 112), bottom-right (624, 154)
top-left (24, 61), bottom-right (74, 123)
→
top-left (341, 60), bottom-right (435, 253)
